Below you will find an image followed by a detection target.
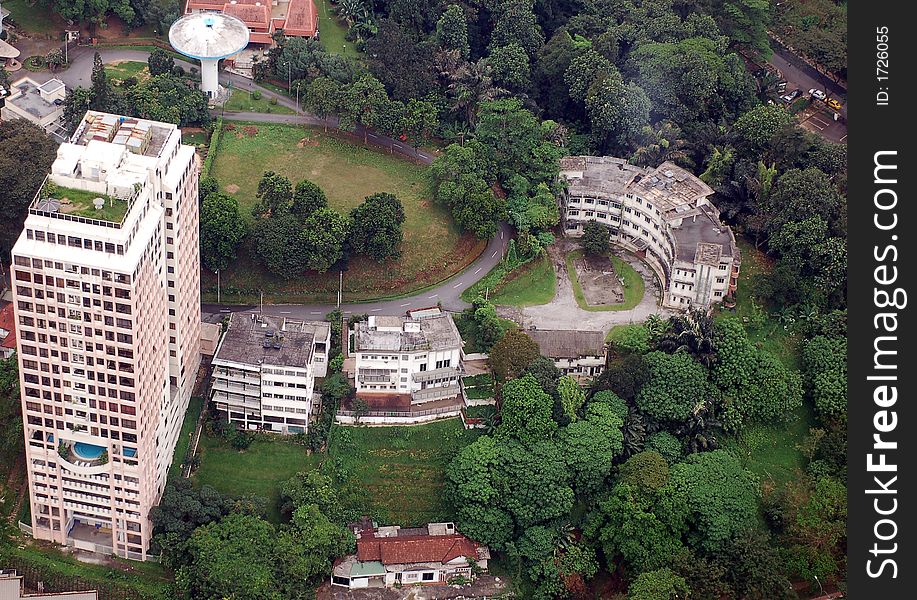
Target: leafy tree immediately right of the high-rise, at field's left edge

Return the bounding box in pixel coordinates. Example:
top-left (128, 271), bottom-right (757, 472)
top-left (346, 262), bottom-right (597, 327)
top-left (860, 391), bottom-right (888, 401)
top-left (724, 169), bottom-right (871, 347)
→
top-left (200, 192), bottom-right (247, 271)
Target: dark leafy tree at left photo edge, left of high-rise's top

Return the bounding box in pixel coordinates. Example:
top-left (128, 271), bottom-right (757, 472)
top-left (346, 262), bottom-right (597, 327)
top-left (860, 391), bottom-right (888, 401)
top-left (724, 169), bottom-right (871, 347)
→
top-left (0, 122), bottom-right (56, 253)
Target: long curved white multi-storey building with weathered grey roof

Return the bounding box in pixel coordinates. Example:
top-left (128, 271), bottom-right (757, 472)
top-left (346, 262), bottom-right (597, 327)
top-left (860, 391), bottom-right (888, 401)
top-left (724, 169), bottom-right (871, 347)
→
top-left (560, 156), bottom-right (741, 309)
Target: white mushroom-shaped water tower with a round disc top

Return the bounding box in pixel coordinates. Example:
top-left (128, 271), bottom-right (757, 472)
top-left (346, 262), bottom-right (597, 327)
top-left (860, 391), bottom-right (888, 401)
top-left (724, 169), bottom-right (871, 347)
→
top-left (169, 12), bottom-right (248, 98)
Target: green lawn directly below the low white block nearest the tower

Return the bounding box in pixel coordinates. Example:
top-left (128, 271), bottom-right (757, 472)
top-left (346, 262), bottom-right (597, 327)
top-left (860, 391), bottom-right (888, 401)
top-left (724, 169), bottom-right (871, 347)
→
top-left (191, 435), bottom-right (321, 523)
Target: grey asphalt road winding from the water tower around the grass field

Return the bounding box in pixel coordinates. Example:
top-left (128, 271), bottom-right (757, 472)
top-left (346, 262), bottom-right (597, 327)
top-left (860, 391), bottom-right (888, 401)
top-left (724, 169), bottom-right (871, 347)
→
top-left (35, 48), bottom-right (512, 322)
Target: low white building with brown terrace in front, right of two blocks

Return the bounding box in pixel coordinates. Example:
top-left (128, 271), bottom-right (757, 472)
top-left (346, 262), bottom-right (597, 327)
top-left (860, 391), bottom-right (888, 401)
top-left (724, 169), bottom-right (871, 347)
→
top-left (350, 309), bottom-right (462, 404)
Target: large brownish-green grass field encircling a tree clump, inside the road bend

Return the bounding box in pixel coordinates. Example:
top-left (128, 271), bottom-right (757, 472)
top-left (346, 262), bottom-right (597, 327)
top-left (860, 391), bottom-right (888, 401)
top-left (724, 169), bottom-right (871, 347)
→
top-left (203, 123), bottom-right (486, 302)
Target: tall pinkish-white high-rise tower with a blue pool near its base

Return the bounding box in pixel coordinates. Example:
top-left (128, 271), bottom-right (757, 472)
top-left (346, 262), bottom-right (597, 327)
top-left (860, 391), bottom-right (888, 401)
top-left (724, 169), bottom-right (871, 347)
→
top-left (12, 111), bottom-right (200, 559)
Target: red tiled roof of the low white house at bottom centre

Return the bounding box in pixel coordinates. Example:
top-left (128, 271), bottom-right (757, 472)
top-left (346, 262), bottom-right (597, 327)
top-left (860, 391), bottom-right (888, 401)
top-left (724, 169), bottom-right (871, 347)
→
top-left (357, 533), bottom-right (478, 565)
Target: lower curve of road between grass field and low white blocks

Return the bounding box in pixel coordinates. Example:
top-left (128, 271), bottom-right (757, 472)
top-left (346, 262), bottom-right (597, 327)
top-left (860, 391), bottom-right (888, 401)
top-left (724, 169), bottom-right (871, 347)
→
top-left (201, 223), bottom-right (512, 323)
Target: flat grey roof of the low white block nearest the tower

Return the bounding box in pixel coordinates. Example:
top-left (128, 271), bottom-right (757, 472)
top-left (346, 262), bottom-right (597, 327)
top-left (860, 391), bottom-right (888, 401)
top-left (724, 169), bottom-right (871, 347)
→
top-left (213, 315), bottom-right (315, 369)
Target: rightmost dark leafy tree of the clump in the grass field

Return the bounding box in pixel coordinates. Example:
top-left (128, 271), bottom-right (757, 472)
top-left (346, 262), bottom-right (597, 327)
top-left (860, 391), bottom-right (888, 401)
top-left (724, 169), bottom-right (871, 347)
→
top-left (349, 192), bottom-right (404, 262)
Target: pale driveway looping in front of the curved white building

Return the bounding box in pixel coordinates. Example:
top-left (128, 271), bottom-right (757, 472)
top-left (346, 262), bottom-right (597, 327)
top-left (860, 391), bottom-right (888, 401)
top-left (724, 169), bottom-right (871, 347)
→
top-left (497, 238), bottom-right (671, 331)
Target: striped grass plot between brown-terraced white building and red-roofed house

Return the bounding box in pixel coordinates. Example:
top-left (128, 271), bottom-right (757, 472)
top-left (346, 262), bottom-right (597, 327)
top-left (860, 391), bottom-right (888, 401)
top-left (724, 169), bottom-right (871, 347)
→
top-left (330, 419), bottom-right (479, 526)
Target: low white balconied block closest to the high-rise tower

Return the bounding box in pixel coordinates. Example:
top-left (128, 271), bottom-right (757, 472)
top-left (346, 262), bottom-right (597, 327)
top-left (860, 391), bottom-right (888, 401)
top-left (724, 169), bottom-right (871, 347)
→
top-left (210, 314), bottom-right (331, 434)
